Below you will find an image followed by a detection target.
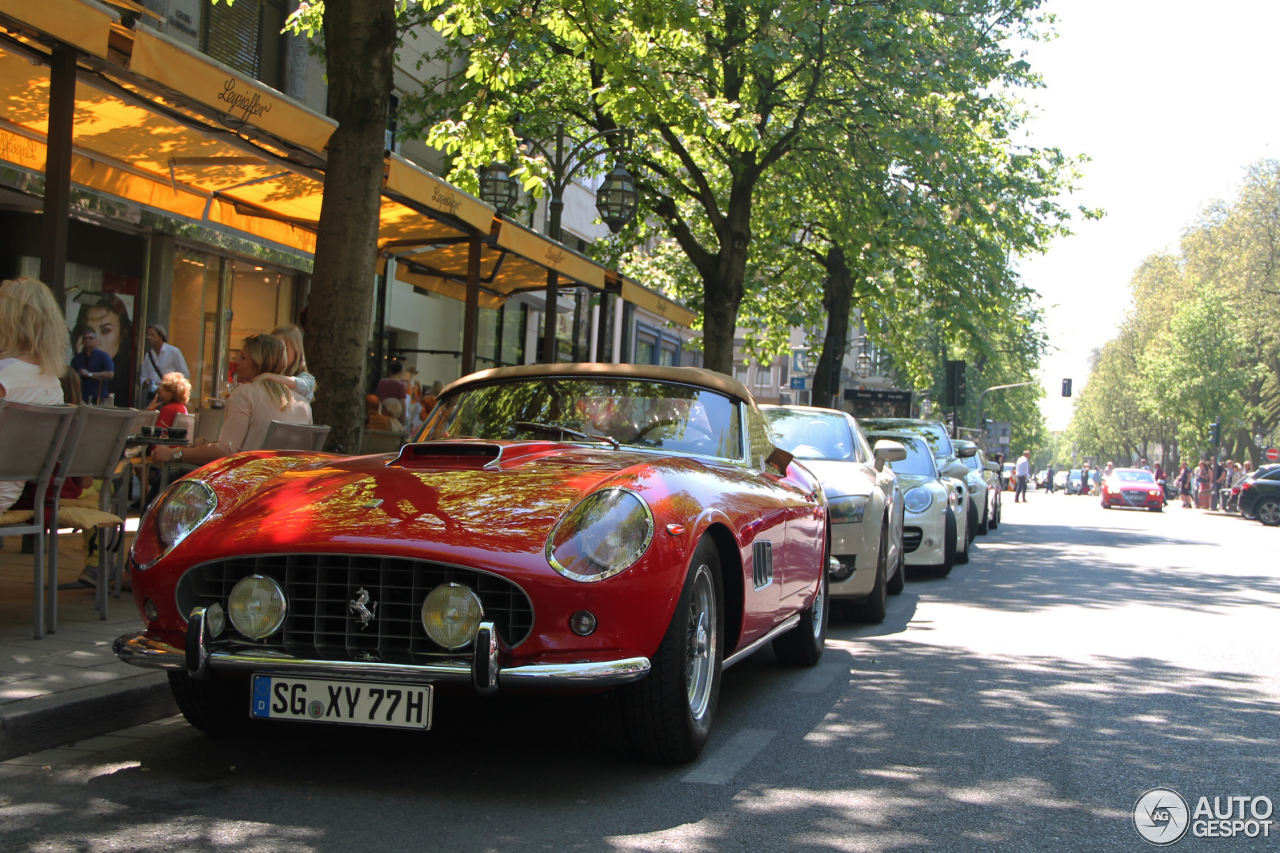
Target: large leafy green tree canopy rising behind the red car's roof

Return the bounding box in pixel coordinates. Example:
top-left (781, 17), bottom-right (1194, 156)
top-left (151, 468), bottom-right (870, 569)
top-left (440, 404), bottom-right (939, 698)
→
top-left (404, 0), bottom-right (1068, 371)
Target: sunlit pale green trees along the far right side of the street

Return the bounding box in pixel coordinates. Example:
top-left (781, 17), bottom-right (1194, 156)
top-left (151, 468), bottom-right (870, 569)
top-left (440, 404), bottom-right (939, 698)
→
top-left (1070, 160), bottom-right (1280, 467)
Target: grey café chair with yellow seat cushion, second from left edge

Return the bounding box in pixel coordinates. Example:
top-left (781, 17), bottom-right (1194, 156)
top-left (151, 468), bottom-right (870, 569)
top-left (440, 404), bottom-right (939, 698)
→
top-left (47, 406), bottom-right (138, 634)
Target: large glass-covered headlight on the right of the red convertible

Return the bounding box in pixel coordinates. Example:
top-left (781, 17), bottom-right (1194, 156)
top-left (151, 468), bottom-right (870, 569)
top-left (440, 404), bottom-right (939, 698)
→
top-left (547, 489), bottom-right (653, 583)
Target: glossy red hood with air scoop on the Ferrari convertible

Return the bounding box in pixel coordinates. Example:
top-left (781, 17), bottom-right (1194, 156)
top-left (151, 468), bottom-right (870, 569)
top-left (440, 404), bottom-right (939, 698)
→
top-left (192, 442), bottom-right (680, 560)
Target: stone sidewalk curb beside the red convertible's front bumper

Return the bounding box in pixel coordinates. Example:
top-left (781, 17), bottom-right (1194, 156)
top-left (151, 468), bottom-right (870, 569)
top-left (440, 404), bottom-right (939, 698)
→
top-left (0, 672), bottom-right (178, 761)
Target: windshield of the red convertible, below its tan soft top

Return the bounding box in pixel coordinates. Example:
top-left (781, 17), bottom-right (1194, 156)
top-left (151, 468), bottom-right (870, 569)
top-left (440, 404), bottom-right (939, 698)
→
top-left (417, 377), bottom-right (742, 459)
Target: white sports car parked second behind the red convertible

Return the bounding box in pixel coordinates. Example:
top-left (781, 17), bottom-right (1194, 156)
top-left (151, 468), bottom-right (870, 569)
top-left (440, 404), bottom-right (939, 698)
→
top-left (867, 432), bottom-right (968, 576)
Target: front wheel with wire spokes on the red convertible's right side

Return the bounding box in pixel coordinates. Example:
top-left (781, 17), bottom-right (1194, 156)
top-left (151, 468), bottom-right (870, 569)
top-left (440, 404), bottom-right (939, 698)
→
top-left (620, 537), bottom-right (727, 763)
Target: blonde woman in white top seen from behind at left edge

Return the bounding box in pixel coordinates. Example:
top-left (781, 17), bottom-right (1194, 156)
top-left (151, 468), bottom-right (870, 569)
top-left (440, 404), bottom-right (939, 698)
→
top-left (0, 278), bottom-right (67, 512)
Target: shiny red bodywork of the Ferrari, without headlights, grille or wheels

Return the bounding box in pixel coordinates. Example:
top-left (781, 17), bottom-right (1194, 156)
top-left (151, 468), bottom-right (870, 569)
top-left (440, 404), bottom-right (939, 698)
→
top-left (133, 439), bottom-right (827, 665)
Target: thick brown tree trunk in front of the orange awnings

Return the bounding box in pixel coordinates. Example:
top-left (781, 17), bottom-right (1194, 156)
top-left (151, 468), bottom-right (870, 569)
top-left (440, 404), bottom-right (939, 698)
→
top-left (306, 0), bottom-right (396, 453)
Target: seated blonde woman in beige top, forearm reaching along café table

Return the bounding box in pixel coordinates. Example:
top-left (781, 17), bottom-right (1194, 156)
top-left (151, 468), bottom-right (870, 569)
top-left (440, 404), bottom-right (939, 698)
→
top-left (151, 334), bottom-right (311, 465)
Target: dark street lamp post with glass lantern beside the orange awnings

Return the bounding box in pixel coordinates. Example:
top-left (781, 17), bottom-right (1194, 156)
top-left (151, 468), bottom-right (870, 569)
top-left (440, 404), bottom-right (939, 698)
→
top-left (504, 123), bottom-right (640, 364)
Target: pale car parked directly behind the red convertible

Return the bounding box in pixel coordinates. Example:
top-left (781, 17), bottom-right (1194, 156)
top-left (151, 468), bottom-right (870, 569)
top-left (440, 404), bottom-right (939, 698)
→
top-left (760, 406), bottom-right (906, 622)
